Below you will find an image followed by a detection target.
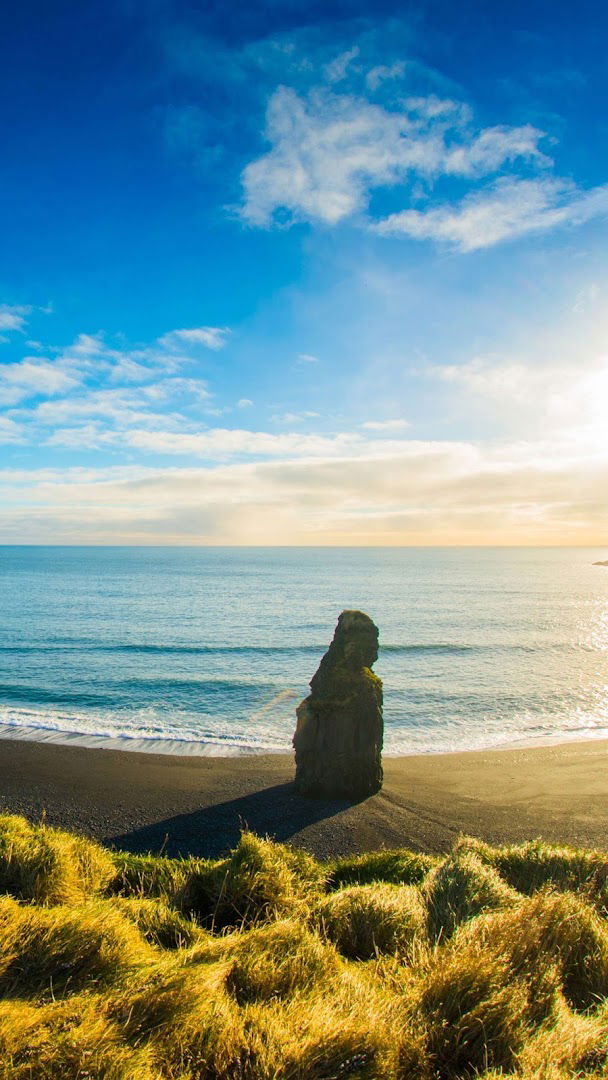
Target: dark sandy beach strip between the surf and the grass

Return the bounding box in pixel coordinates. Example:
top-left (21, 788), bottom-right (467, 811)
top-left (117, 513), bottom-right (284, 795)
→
top-left (0, 740), bottom-right (608, 858)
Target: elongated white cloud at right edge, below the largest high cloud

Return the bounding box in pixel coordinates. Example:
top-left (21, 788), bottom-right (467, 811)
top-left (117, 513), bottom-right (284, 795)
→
top-left (374, 177), bottom-right (608, 252)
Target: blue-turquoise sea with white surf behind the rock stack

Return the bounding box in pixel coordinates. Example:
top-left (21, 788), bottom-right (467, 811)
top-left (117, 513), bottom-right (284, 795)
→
top-left (0, 546), bottom-right (608, 754)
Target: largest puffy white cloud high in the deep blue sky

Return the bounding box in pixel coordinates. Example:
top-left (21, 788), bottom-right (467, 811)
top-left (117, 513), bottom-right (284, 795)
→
top-left (242, 86), bottom-right (548, 226)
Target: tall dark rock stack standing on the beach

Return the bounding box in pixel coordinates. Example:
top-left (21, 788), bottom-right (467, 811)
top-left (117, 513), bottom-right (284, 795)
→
top-left (294, 611), bottom-right (383, 799)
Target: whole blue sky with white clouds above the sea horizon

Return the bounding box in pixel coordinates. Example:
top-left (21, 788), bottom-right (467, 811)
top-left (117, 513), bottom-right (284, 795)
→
top-left (0, 0), bottom-right (608, 545)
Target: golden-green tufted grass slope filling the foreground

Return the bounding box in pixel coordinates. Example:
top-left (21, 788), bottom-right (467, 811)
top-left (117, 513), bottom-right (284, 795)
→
top-left (0, 816), bottom-right (608, 1080)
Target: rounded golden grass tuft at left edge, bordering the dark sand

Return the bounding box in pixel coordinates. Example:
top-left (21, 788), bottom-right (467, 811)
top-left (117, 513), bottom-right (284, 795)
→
top-left (0, 814), bottom-right (114, 904)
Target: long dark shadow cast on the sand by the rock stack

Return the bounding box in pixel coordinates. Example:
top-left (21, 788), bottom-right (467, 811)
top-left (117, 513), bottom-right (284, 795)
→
top-left (109, 783), bottom-right (353, 859)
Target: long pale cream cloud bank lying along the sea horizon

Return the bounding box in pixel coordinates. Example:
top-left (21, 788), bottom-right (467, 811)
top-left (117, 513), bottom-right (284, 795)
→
top-left (0, 441), bottom-right (608, 544)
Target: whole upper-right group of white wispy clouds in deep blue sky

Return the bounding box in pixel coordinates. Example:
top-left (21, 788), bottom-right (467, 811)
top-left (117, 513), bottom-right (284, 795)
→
top-left (240, 49), bottom-right (608, 252)
